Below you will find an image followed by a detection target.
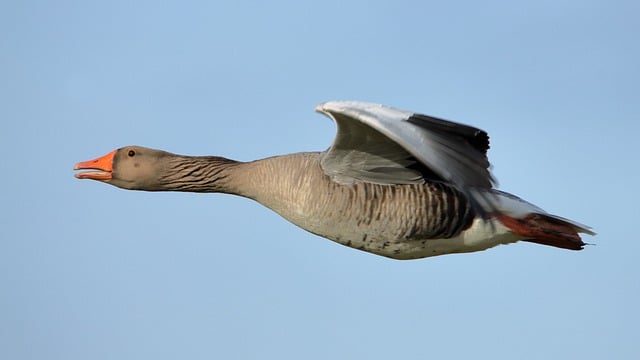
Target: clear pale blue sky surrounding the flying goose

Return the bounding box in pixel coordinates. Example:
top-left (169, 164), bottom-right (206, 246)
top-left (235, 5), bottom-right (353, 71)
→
top-left (0, 0), bottom-right (640, 360)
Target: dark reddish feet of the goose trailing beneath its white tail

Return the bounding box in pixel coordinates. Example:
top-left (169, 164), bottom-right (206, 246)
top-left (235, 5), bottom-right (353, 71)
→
top-left (498, 214), bottom-right (586, 250)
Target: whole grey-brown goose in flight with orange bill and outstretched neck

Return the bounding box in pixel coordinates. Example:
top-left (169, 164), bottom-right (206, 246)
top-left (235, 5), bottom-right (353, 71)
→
top-left (74, 101), bottom-right (595, 260)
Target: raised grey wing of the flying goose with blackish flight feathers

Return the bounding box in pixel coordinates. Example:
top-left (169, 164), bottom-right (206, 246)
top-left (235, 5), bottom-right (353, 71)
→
top-left (316, 101), bottom-right (495, 211)
